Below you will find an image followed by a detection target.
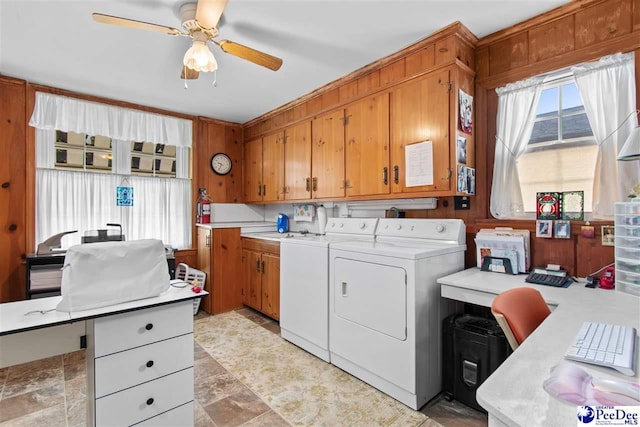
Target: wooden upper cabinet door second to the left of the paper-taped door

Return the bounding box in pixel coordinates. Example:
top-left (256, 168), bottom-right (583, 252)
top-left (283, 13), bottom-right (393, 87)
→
top-left (311, 110), bottom-right (344, 199)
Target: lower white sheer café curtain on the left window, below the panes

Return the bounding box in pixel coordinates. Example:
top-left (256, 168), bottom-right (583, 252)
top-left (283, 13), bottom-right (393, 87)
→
top-left (36, 169), bottom-right (191, 248)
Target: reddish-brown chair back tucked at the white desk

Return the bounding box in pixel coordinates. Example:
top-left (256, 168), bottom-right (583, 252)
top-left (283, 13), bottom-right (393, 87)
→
top-left (491, 287), bottom-right (551, 350)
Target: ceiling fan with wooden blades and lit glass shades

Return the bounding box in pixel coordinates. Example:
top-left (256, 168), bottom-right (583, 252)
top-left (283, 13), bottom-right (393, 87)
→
top-left (92, 0), bottom-right (282, 79)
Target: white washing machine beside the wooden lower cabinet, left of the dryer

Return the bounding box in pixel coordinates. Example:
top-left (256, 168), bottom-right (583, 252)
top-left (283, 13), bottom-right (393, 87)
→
top-left (280, 218), bottom-right (378, 362)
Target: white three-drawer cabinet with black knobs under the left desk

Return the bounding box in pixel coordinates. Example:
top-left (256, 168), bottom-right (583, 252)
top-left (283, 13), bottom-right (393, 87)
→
top-left (87, 300), bottom-right (194, 426)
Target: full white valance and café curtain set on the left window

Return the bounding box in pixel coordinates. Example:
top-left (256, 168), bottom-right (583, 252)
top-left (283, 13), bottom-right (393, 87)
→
top-left (30, 93), bottom-right (192, 249)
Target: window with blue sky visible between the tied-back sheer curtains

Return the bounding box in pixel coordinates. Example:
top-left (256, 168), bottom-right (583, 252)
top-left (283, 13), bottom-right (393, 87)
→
top-left (517, 77), bottom-right (598, 213)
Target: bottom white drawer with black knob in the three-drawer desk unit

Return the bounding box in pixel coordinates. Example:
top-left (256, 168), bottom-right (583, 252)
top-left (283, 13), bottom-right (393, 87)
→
top-left (95, 368), bottom-right (193, 426)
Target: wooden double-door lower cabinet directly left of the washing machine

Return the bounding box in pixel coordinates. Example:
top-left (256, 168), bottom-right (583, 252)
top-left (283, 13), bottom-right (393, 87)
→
top-left (242, 238), bottom-right (280, 320)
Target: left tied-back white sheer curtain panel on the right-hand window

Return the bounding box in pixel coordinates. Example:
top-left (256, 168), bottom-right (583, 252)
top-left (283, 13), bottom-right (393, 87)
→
top-left (490, 77), bottom-right (544, 219)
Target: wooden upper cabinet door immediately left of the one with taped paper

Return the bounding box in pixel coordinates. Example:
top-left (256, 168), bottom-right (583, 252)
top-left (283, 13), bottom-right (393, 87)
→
top-left (345, 93), bottom-right (389, 196)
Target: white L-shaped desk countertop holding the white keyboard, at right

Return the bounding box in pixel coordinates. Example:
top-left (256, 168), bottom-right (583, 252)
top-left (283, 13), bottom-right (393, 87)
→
top-left (438, 268), bottom-right (640, 426)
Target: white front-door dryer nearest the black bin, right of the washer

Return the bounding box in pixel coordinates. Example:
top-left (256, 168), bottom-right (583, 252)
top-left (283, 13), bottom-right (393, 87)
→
top-left (329, 219), bottom-right (466, 410)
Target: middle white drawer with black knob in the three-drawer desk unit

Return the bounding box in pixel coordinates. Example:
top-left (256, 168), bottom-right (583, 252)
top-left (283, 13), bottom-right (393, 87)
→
top-left (95, 334), bottom-right (193, 398)
